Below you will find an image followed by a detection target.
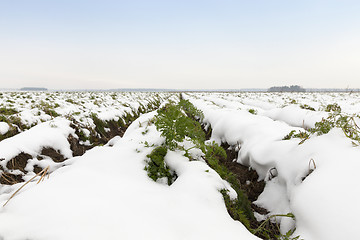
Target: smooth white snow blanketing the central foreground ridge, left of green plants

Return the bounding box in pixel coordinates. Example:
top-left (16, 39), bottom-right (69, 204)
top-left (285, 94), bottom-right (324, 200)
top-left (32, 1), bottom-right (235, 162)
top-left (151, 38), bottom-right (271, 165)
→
top-left (0, 110), bottom-right (258, 240)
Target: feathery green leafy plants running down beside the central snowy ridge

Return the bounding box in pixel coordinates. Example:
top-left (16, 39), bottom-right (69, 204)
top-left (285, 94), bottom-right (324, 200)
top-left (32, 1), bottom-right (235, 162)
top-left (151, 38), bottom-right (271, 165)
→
top-left (145, 99), bottom-right (299, 239)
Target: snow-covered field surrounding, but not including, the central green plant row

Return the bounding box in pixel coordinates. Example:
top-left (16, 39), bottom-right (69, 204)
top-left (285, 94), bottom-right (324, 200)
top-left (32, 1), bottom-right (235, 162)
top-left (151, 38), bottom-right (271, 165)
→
top-left (0, 92), bottom-right (360, 240)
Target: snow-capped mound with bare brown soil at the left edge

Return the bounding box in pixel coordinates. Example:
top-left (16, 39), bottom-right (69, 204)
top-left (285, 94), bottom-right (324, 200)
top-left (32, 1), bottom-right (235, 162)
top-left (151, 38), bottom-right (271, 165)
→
top-left (0, 118), bottom-right (76, 202)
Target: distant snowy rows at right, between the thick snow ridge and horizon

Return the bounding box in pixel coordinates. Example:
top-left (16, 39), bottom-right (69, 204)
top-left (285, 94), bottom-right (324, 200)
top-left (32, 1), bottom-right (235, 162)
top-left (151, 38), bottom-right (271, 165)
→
top-left (189, 92), bottom-right (360, 129)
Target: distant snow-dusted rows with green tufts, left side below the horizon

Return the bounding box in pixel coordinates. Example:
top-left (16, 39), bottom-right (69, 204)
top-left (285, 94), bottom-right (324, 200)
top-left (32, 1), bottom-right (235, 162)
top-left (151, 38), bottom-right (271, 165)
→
top-left (0, 92), bottom-right (173, 139)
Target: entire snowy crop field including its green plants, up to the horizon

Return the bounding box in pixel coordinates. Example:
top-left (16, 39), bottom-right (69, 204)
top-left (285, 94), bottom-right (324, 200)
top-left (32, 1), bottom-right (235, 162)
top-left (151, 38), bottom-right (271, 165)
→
top-left (0, 92), bottom-right (360, 240)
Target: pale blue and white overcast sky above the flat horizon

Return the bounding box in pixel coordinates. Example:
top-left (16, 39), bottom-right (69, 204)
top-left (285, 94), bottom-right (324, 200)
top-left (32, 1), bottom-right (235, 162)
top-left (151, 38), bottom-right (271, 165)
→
top-left (0, 0), bottom-right (360, 89)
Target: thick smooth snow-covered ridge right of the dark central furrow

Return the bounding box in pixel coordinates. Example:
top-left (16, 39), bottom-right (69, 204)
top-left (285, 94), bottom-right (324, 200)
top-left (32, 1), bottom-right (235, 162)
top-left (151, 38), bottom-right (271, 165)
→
top-left (190, 94), bottom-right (360, 240)
